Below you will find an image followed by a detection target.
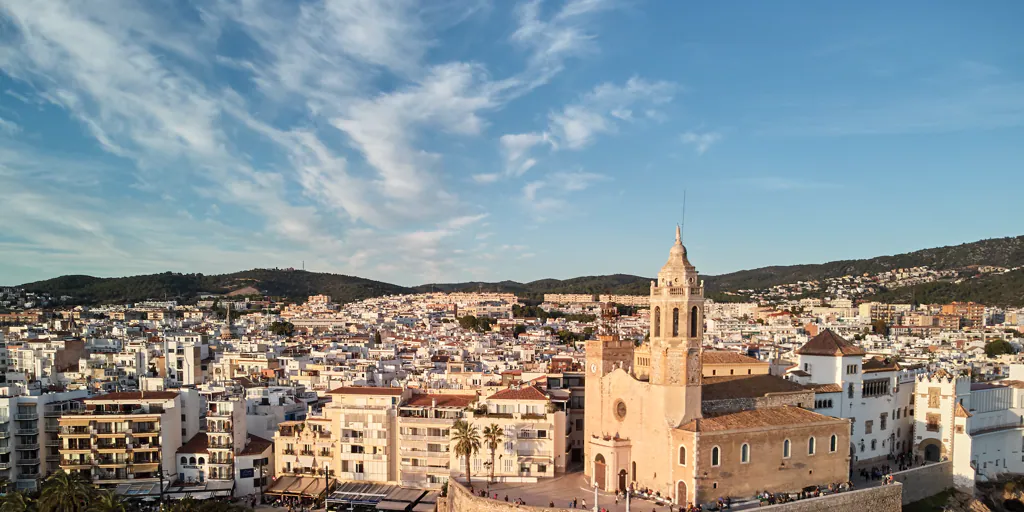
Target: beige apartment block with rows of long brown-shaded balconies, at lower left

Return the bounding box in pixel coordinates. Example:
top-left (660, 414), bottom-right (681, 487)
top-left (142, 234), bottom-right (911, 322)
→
top-left (58, 391), bottom-right (188, 488)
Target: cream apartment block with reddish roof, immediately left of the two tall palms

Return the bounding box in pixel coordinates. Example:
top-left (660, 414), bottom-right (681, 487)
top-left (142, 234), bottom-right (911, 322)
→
top-left (397, 393), bottom-right (477, 488)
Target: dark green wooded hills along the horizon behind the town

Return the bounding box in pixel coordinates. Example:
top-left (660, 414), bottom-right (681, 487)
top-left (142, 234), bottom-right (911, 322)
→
top-left (14, 237), bottom-right (1024, 305)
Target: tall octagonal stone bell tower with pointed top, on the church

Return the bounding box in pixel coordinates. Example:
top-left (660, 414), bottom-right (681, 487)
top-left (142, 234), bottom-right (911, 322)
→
top-left (650, 226), bottom-right (703, 401)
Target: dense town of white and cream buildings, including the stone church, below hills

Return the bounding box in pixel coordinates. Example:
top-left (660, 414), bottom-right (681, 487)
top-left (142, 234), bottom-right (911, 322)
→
top-left (0, 233), bottom-right (1024, 510)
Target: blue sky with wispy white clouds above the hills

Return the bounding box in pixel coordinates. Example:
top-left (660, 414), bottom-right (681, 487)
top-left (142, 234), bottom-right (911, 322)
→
top-left (0, 0), bottom-right (1024, 285)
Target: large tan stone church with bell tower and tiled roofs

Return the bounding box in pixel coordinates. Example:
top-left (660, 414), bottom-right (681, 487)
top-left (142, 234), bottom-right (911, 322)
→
top-left (584, 227), bottom-right (850, 505)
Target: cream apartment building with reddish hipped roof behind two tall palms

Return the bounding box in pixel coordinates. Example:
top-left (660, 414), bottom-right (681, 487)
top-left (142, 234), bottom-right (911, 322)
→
top-left (462, 386), bottom-right (566, 482)
